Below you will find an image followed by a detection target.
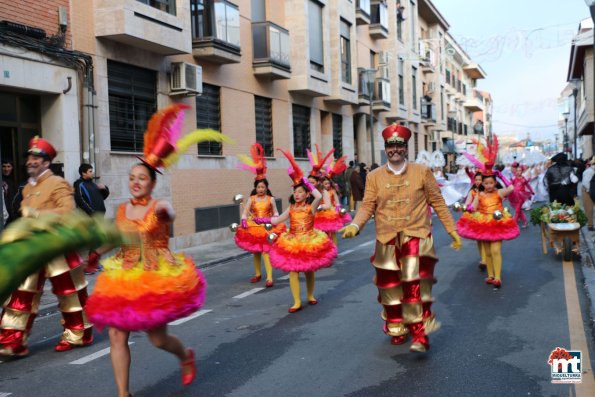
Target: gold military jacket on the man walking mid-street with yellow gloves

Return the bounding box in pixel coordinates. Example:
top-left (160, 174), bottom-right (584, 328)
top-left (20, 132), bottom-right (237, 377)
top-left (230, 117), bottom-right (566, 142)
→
top-left (353, 162), bottom-right (456, 244)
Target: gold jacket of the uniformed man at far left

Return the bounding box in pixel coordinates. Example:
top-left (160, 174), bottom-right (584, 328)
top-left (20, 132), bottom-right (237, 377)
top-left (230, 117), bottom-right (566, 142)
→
top-left (21, 170), bottom-right (76, 214)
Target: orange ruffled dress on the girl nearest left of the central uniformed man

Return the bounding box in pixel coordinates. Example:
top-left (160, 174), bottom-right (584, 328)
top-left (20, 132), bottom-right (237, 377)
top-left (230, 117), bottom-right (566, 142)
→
top-left (270, 204), bottom-right (337, 272)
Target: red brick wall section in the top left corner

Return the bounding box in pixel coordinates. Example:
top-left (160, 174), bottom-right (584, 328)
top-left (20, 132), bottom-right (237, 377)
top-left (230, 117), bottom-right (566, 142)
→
top-left (0, 0), bottom-right (71, 48)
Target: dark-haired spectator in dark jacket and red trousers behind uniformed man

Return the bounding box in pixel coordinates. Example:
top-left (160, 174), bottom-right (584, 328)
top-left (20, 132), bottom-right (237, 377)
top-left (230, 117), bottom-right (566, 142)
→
top-left (74, 164), bottom-right (109, 274)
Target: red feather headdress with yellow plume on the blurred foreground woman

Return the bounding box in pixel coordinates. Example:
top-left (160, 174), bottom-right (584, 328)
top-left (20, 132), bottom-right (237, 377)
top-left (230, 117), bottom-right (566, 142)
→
top-left (137, 104), bottom-right (233, 173)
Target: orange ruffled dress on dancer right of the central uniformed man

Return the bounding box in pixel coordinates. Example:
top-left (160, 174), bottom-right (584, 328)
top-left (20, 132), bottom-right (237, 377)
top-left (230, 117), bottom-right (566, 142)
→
top-left (457, 191), bottom-right (520, 241)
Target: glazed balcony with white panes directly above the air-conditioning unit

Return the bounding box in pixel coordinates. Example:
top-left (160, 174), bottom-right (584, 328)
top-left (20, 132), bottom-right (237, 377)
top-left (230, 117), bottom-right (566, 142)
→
top-left (190, 0), bottom-right (241, 63)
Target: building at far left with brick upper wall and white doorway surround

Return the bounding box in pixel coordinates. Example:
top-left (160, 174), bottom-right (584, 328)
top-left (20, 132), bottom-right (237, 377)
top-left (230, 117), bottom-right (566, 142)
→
top-left (0, 0), bottom-right (84, 182)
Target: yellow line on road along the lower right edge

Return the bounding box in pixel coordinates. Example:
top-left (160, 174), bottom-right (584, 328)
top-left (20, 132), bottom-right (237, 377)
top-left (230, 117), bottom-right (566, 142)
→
top-left (562, 261), bottom-right (595, 397)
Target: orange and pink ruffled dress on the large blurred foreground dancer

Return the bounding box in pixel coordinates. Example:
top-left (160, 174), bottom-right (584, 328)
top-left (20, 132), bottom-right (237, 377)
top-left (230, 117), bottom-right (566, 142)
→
top-left (85, 202), bottom-right (207, 331)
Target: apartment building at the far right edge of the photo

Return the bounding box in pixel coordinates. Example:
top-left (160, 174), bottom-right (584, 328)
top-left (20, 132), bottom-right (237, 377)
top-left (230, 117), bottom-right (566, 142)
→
top-left (559, 18), bottom-right (595, 159)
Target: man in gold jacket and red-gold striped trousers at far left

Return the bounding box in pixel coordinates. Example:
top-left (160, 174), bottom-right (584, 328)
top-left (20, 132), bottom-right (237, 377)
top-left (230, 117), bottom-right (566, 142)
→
top-left (0, 137), bottom-right (93, 357)
